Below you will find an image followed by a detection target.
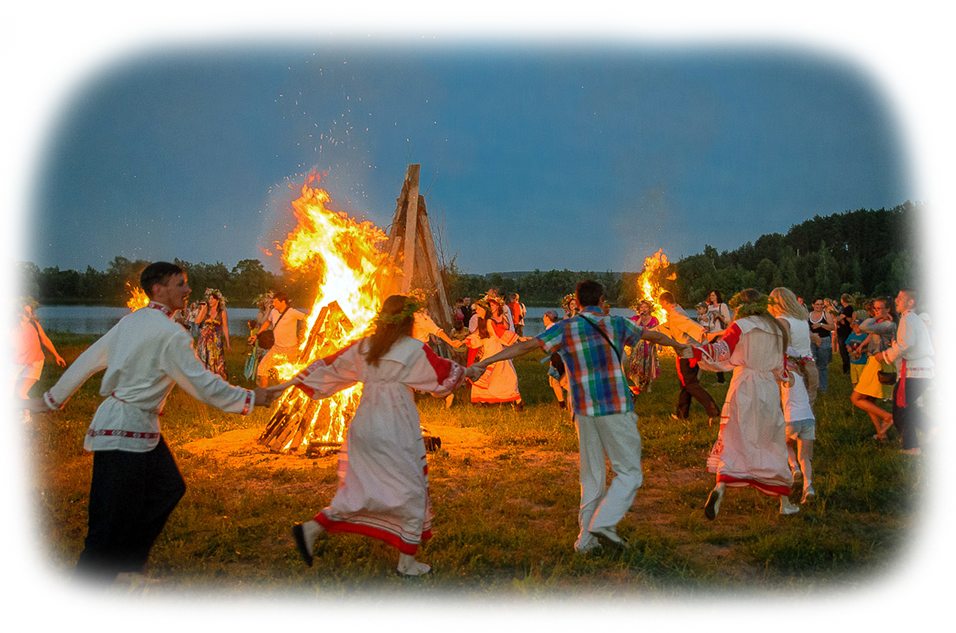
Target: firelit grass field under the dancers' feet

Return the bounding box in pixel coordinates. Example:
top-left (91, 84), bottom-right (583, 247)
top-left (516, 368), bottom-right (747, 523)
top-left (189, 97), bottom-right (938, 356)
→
top-left (0, 334), bottom-right (956, 631)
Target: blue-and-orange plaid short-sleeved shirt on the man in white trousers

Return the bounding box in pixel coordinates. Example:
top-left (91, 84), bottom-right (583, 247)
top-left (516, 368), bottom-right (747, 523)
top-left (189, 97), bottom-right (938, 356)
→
top-left (537, 307), bottom-right (644, 417)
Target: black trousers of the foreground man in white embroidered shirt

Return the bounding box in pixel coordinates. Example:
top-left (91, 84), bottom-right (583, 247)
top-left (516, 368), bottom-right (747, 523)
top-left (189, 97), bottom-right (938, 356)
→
top-left (63, 437), bottom-right (186, 600)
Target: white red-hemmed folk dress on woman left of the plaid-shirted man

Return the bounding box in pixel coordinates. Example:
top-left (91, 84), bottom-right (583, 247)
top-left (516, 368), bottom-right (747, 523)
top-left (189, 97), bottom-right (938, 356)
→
top-left (296, 337), bottom-right (465, 555)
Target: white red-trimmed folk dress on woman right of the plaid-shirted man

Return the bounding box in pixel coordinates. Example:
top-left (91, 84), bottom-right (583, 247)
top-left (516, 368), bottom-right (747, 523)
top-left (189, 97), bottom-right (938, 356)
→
top-left (694, 317), bottom-right (793, 497)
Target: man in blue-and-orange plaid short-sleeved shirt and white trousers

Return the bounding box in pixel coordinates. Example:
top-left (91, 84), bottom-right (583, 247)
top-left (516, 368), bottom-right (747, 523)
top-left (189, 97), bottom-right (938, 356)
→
top-left (477, 280), bottom-right (690, 554)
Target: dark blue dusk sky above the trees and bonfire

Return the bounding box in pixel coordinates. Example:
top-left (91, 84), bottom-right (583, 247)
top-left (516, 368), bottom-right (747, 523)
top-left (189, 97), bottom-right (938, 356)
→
top-left (0, 0), bottom-right (956, 273)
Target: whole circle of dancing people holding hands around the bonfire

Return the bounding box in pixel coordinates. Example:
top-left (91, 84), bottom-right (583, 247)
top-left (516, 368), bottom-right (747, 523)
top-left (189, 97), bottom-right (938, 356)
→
top-left (0, 262), bottom-right (940, 616)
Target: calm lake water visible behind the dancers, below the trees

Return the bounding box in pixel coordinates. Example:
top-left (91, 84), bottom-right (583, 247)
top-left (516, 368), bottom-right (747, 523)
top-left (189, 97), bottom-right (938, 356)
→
top-left (37, 306), bottom-right (634, 336)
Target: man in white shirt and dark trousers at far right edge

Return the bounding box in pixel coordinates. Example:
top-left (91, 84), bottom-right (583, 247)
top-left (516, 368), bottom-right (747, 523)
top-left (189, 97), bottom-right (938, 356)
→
top-left (874, 288), bottom-right (939, 455)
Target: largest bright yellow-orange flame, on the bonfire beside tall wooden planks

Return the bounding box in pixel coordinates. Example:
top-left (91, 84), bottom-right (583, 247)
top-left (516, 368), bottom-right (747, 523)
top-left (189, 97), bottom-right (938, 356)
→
top-left (268, 173), bottom-right (391, 450)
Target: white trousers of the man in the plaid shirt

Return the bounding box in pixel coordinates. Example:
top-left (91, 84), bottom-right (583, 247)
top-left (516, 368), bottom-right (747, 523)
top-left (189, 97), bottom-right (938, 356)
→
top-left (574, 411), bottom-right (644, 552)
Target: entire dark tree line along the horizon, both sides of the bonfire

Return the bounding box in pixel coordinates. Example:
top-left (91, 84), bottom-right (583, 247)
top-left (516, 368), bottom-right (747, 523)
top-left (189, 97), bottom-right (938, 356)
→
top-left (0, 200), bottom-right (956, 333)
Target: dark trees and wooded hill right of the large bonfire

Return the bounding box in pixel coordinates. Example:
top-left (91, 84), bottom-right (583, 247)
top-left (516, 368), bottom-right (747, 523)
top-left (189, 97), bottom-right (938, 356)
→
top-left (446, 200), bottom-right (956, 332)
